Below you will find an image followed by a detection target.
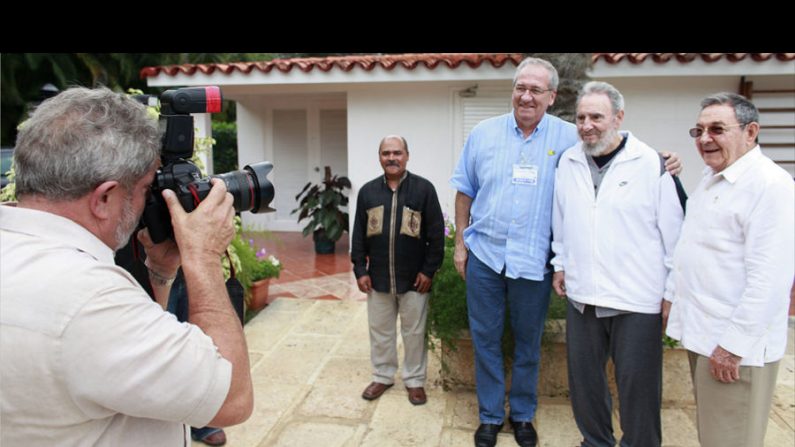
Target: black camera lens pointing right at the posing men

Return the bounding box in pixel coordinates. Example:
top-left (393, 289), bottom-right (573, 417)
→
top-left (213, 161), bottom-right (273, 213)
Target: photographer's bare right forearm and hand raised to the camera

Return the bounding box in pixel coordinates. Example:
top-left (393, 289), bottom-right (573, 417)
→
top-left (163, 179), bottom-right (254, 427)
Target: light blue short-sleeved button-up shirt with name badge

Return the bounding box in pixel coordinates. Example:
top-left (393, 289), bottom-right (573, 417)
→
top-left (450, 112), bottom-right (578, 281)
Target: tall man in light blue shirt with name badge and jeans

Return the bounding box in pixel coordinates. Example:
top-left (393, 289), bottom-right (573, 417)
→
top-left (450, 58), bottom-right (680, 447)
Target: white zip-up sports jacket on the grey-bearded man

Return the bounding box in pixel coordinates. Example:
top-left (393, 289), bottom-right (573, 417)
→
top-left (552, 131), bottom-right (684, 314)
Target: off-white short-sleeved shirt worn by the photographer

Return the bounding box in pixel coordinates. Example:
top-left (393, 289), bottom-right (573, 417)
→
top-left (0, 206), bottom-right (232, 447)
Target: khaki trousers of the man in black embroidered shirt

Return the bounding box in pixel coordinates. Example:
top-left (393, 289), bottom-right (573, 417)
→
top-left (367, 290), bottom-right (428, 388)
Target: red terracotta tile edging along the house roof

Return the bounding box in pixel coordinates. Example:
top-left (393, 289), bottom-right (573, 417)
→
top-left (140, 53), bottom-right (795, 79)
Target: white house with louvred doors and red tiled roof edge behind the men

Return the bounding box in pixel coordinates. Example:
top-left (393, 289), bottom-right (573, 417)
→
top-left (141, 53), bottom-right (795, 231)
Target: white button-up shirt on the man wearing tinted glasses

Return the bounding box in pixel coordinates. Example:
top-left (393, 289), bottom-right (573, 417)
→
top-left (666, 146), bottom-right (795, 366)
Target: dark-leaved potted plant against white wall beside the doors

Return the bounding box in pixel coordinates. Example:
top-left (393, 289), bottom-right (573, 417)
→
top-left (290, 166), bottom-right (351, 254)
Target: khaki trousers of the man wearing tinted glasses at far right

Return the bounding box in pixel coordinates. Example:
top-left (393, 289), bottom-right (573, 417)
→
top-left (687, 351), bottom-right (781, 447)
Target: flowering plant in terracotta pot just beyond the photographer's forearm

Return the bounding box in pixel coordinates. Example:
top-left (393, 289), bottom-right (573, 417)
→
top-left (232, 235), bottom-right (283, 310)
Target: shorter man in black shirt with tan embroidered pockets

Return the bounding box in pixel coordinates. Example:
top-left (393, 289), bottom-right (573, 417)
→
top-left (351, 135), bottom-right (444, 405)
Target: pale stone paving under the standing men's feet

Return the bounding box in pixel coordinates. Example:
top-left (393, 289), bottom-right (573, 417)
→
top-left (193, 272), bottom-right (795, 447)
